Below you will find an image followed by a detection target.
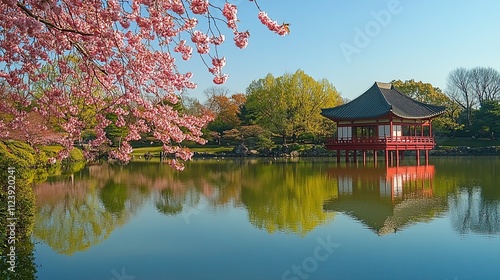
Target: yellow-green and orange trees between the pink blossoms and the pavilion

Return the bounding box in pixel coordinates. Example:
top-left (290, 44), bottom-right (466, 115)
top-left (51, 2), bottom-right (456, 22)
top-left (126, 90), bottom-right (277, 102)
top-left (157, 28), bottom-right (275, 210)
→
top-left (183, 70), bottom-right (343, 149)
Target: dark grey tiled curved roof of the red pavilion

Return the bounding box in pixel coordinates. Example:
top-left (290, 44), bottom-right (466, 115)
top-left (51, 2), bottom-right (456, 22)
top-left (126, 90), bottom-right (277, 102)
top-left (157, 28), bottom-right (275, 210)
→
top-left (321, 83), bottom-right (445, 121)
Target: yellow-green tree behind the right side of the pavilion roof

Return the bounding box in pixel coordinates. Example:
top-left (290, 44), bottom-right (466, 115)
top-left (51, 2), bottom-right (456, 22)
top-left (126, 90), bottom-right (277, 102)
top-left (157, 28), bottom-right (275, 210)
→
top-left (392, 80), bottom-right (463, 134)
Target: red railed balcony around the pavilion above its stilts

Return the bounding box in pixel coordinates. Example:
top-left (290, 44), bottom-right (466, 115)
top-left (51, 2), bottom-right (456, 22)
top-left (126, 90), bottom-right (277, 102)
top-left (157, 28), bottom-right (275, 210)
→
top-left (325, 136), bottom-right (436, 151)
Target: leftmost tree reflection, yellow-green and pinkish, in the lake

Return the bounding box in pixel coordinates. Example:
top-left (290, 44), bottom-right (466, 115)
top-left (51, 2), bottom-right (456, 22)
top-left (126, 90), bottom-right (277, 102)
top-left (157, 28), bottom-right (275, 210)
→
top-left (33, 166), bottom-right (147, 255)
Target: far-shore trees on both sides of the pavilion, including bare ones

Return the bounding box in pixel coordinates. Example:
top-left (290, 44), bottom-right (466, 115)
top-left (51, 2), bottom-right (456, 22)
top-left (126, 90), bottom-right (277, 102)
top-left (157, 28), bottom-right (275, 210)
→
top-left (179, 67), bottom-right (500, 149)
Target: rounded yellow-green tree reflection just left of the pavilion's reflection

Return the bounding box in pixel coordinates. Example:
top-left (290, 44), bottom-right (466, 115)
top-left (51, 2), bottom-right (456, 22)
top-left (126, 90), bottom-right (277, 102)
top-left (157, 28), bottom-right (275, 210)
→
top-left (241, 163), bottom-right (338, 236)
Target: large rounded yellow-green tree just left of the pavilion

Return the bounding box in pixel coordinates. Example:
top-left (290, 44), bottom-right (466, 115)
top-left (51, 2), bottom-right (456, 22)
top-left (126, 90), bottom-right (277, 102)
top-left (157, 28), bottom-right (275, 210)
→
top-left (245, 70), bottom-right (342, 143)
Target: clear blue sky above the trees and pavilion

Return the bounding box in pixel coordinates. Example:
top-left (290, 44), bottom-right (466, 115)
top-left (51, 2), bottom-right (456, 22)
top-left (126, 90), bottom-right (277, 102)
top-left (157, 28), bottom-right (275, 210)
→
top-left (184, 0), bottom-right (500, 100)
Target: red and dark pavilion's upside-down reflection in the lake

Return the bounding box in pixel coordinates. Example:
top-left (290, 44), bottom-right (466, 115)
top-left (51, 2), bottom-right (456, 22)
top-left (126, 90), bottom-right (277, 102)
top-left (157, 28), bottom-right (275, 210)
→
top-left (323, 165), bottom-right (446, 235)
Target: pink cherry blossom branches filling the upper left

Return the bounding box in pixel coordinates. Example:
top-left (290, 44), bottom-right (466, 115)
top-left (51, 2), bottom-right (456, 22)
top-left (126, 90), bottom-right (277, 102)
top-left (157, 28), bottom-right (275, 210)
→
top-left (0, 0), bottom-right (287, 169)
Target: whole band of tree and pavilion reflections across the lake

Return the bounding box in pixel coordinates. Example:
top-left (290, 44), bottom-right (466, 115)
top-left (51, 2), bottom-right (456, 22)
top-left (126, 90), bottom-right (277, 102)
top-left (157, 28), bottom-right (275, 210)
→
top-left (33, 159), bottom-right (500, 254)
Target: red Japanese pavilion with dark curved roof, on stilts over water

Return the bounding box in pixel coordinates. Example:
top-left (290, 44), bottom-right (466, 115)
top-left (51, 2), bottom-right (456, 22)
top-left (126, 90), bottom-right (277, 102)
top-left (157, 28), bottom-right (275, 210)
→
top-left (321, 82), bottom-right (445, 166)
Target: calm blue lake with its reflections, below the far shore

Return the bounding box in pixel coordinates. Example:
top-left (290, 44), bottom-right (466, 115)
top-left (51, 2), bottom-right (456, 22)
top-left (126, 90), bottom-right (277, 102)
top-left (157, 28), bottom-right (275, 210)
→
top-left (32, 157), bottom-right (500, 280)
